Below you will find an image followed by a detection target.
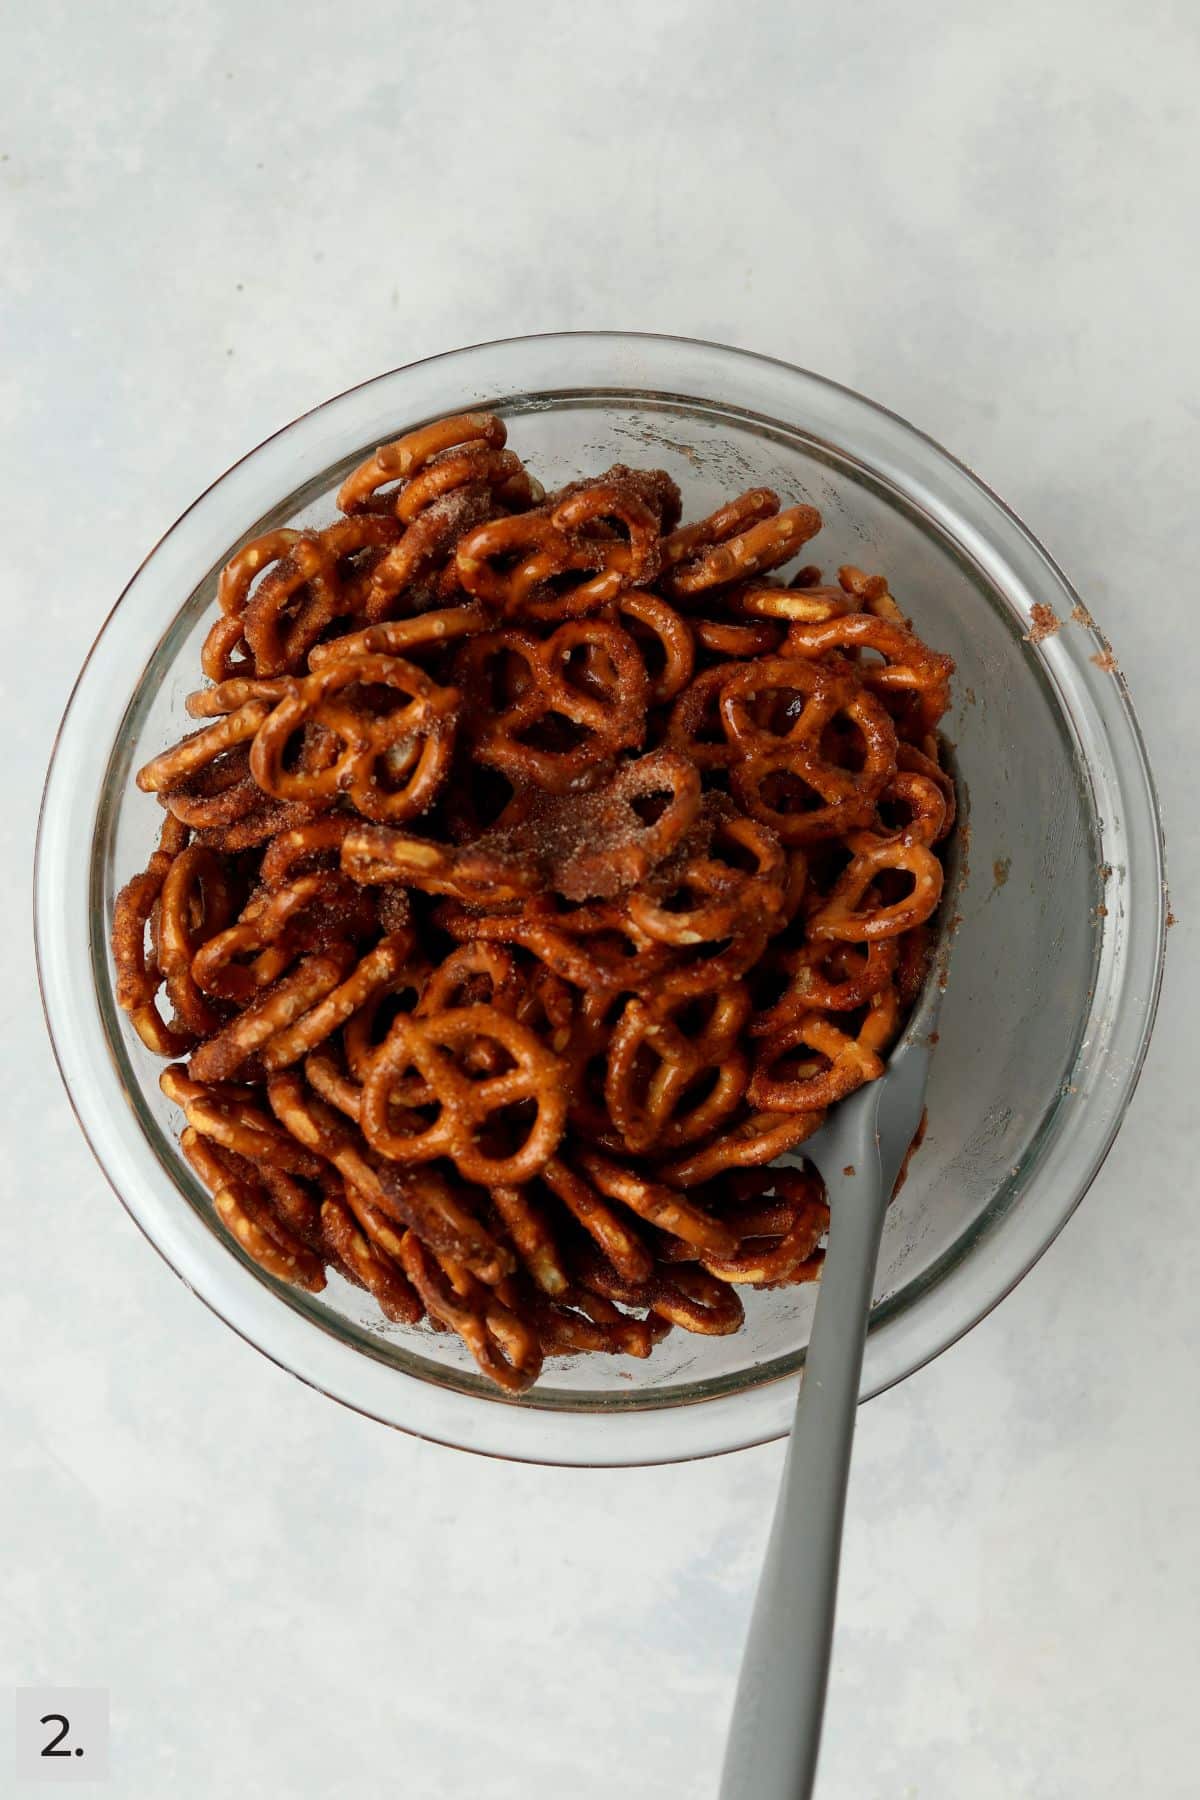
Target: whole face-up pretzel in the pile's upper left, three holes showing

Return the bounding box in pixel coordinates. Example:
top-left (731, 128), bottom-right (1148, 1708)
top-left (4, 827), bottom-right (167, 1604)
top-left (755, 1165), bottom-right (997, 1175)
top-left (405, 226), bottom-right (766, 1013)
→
top-left (250, 657), bottom-right (459, 821)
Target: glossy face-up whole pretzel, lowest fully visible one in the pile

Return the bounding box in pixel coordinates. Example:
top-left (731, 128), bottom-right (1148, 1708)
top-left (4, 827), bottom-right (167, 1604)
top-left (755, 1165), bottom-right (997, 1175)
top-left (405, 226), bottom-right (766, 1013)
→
top-left (362, 1006), bottom-right (567, 1183)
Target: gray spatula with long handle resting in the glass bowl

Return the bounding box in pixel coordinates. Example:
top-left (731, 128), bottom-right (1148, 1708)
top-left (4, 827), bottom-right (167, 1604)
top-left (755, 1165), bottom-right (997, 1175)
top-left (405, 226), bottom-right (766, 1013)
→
top-left (721, 869), bottom-right (954, 1800)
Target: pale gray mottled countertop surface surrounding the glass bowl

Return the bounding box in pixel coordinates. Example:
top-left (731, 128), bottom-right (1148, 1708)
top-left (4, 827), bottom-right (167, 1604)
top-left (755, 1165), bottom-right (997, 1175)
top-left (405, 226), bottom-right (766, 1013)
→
top-left (0, 0), bottom-right (1200, 1800)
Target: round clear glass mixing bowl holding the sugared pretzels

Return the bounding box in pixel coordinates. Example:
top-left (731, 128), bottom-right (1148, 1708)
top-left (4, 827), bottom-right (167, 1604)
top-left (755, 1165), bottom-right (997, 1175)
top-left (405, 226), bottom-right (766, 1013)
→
top-left (36, 333), bottom-right (1166, 1463)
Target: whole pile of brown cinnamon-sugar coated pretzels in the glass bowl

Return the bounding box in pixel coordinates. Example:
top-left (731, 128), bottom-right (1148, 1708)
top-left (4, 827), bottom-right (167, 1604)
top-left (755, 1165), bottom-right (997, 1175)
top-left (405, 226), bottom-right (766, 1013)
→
top-left (112, 412), bottom-right (954, 1391)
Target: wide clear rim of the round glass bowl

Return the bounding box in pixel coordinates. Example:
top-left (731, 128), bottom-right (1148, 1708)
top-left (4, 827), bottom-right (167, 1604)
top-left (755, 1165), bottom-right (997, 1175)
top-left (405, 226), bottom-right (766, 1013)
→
top-left (34, 331), bottom-right (1166, 1465)
